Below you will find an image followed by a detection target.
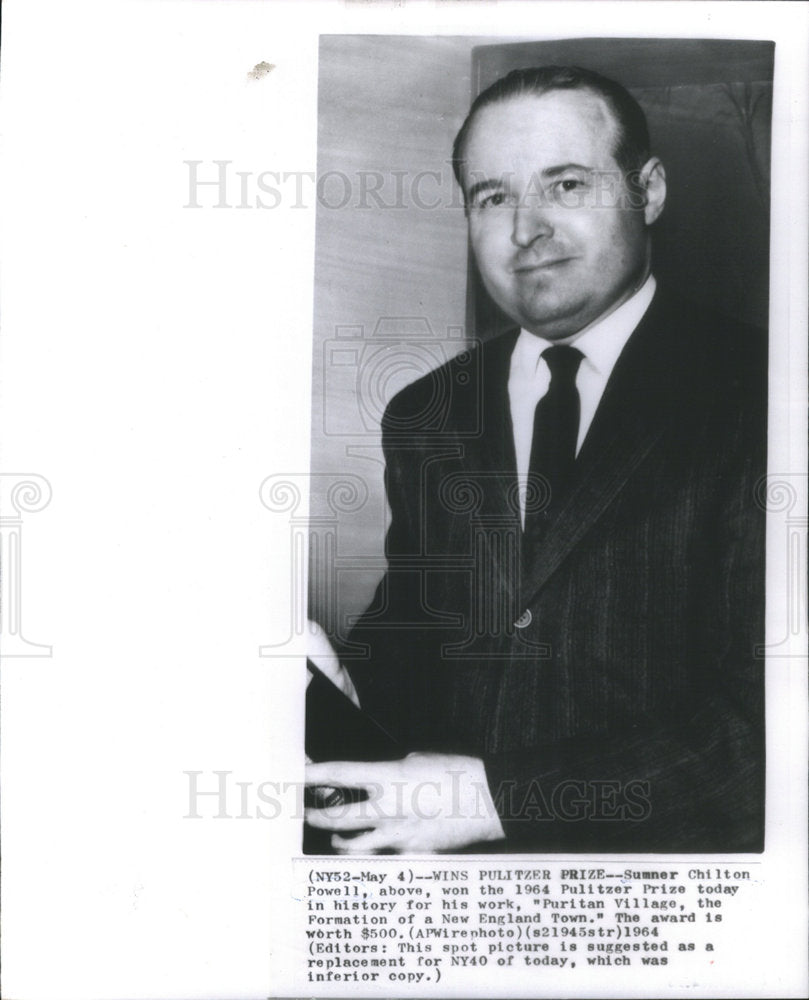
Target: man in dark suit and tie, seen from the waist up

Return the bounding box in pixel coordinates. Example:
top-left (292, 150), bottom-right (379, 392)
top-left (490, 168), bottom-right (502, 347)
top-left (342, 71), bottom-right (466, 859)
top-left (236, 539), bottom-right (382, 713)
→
top-left (307, 67), bottom-right (767, 853)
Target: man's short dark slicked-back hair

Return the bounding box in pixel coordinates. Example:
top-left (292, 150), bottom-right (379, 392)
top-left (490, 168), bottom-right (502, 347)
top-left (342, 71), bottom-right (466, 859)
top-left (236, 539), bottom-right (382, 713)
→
top-left (452, 66), bottom-right (650, 190)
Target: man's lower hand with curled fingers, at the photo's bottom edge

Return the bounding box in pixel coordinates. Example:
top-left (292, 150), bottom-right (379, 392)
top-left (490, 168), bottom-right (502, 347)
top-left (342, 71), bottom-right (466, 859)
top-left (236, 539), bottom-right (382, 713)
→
top-left (306, 753), bottom-right (504, 854)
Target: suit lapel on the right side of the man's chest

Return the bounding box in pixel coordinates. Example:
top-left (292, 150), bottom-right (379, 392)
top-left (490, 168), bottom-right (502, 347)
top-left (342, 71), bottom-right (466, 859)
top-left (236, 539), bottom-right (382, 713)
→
top-left (521, 295), bottom-right (682, 605)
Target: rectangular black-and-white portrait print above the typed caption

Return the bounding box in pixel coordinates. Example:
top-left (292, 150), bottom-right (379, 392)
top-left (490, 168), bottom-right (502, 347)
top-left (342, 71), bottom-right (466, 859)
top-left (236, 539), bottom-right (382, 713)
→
top-left (307, 36), bottom-right (774, 854)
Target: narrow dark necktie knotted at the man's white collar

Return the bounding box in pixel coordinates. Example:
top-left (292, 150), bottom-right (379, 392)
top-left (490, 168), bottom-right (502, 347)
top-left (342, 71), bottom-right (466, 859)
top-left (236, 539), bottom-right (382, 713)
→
top-left (525, 345), bottom-right (584, 538)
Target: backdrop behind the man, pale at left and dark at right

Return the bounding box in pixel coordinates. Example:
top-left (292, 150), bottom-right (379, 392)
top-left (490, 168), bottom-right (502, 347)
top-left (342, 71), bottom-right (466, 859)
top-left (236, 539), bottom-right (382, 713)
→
top-left (309, 35), bottom-right (773, 635)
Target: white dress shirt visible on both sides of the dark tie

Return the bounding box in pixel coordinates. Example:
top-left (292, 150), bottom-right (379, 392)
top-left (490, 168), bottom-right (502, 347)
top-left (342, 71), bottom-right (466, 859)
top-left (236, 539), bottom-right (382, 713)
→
top-left (508, 275), bottom-right (657, 524)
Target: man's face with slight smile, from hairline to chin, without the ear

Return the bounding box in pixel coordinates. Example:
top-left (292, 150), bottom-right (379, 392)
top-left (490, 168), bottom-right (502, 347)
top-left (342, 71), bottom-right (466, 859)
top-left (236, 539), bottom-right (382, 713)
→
top-left (463, 90), bottom-right (650, 340)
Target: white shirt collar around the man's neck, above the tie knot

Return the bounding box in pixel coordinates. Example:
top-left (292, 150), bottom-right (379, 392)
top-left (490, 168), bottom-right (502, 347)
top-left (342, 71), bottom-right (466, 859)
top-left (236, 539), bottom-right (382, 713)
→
top-left (512, 274), bottom-right (657, 376)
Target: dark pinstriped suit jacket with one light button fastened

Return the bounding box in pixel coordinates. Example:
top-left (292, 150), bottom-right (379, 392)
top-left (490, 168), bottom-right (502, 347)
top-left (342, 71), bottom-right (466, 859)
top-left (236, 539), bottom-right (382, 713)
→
top-left (348, 292), bottom-right (767, 852)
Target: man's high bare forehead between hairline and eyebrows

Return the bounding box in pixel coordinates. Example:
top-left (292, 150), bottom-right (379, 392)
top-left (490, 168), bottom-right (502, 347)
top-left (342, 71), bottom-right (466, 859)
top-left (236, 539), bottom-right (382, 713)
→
top-left (464, 89), bottom-right (617, 170)
